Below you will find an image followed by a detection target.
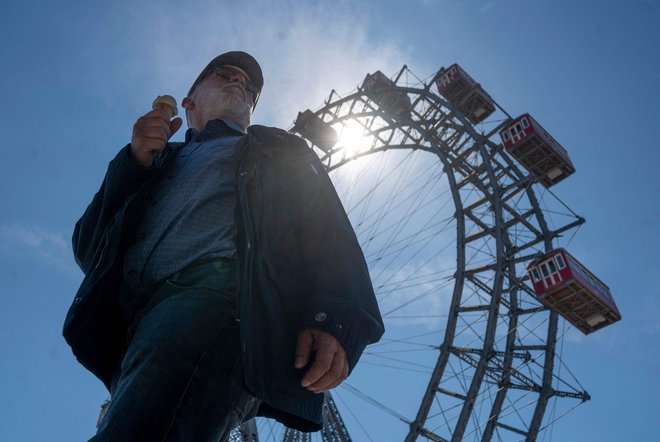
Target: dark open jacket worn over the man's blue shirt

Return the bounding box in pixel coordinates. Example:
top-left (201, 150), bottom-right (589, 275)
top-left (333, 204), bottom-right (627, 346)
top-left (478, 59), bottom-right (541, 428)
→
top-left (63, 126), bottom-right (384, 431)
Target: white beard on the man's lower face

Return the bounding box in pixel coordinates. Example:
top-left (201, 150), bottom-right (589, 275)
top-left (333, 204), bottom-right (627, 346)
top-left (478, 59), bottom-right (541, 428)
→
top-left (195, 88), bottom-right (252, 129)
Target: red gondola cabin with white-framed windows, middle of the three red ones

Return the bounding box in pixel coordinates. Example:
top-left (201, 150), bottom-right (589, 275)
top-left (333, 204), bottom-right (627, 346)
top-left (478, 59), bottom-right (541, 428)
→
top-left (500, 114), bottom-right (575, 187)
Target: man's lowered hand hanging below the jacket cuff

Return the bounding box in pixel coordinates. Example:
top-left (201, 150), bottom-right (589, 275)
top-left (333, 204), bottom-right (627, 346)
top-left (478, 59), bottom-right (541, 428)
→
top-left (294, 328), bottom-right (349, 393)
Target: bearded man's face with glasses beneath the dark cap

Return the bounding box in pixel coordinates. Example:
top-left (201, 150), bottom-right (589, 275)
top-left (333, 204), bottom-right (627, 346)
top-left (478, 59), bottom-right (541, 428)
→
top-left (183, 66), bottom-right (254, 130)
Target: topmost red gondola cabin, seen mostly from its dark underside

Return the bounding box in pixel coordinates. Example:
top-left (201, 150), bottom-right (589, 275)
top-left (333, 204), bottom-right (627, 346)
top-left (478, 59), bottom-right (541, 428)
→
top-left (435, 63), bottom-right (495, 124)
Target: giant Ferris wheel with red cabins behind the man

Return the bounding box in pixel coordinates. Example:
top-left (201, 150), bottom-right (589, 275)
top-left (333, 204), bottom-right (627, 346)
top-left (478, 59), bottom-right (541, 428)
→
top-left (231, 64), bottom-right (620, 442)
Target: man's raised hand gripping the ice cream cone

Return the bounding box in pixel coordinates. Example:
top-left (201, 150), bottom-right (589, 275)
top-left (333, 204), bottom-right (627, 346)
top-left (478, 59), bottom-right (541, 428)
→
top-left (129, 109), bottom-right (183, 167)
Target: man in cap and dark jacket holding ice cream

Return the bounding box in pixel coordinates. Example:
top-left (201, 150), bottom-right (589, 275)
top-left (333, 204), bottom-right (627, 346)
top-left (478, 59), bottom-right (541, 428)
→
top-left (64, 51), bottom-right (383, 441)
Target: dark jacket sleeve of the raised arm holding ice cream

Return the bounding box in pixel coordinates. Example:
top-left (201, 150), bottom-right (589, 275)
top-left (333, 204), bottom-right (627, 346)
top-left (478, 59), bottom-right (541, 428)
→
top-left (72, 145), bottom-right (155, 274)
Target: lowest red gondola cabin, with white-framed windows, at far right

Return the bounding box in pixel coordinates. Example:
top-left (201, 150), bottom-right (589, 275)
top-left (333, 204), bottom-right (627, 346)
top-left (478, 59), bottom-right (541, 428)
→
top-left (527, 249), bottom-right (621, 334)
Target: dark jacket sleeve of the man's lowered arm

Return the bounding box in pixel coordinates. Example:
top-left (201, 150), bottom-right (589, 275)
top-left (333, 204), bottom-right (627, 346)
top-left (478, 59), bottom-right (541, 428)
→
top-left (268, 137), bottom-right (384, 369)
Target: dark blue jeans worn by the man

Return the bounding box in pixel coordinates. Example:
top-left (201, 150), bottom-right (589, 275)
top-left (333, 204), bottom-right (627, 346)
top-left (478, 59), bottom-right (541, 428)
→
top-left (91, 260), bottom-right (259, 442)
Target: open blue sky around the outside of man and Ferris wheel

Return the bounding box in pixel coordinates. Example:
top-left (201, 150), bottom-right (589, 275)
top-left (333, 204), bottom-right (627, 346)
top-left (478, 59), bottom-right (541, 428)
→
top-left (0, 0), bottom-right (660, 441)
